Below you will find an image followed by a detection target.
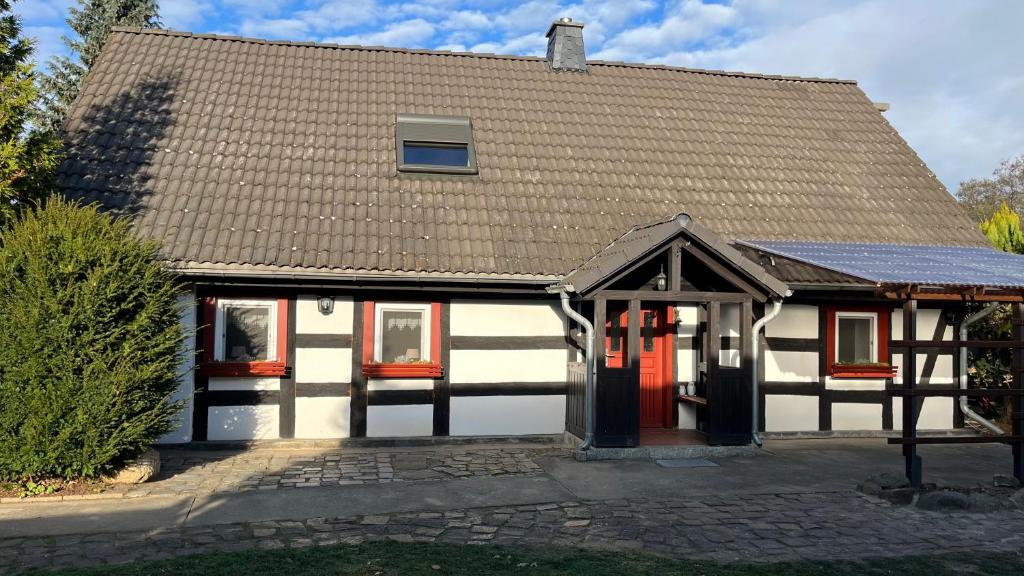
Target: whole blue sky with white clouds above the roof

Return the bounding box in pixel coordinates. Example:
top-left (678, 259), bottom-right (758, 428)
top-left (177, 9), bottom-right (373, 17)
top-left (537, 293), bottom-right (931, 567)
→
top-left (14, 0), bottom-right (1024, 192)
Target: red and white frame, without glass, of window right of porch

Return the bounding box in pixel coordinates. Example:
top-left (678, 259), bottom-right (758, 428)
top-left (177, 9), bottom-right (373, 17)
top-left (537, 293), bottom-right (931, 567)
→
top-left (824, 306), bottom-right (896, 378)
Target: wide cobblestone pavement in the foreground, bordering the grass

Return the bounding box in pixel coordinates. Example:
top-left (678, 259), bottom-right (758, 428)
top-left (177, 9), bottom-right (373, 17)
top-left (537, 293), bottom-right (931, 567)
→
top-left (6, 492), bottom-right (1024, 572)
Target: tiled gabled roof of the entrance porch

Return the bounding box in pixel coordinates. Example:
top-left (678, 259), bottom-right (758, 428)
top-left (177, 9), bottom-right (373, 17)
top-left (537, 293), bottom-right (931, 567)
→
top-left (560, 213), bottom-right (790, 297)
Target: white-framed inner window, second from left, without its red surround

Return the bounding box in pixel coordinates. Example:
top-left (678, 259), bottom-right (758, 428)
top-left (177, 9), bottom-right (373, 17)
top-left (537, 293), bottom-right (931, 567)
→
top-left (374, 303), bottom-right (430, 364)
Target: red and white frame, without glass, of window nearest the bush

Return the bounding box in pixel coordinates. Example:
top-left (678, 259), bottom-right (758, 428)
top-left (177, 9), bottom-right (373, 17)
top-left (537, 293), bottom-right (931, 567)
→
top-left (200, 297), bottom-right (288, 377)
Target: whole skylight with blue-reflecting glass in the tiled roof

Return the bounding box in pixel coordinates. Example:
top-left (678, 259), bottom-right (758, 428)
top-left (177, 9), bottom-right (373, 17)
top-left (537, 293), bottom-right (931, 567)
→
top-left (395, 114), bottom-right (476, 174)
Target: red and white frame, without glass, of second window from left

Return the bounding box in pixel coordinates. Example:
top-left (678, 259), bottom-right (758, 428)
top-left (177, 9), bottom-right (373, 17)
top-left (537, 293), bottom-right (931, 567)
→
top-left (362, 300), bottom-right (443, 378)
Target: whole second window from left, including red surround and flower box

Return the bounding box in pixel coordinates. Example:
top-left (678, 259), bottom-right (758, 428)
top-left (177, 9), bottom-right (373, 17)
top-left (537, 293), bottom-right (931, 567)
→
top-left (362, 301), bottom-right (441, 378)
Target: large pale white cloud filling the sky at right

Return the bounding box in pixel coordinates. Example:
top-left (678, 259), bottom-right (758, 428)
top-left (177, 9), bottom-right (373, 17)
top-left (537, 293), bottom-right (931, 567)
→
top-left (655, 0), bottom-right (1024, 192)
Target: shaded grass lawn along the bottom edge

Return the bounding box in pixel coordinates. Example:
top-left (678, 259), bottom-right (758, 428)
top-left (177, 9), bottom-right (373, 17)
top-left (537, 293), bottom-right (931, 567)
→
top-left (36, 542), bottom-right (1024, 576)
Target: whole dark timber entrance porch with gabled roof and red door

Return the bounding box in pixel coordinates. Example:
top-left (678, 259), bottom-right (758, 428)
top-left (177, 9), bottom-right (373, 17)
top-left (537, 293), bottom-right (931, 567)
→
top-left (561, 213), bottom-right (790, 448)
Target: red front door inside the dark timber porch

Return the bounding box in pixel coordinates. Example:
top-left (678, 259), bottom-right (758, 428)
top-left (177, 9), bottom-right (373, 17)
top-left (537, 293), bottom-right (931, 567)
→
top-left (605, 302), bottom-right (672, 428)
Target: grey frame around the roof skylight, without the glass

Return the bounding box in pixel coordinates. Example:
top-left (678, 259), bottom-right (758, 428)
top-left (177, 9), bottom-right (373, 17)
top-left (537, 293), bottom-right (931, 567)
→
top-left (395, 114), bottom-right (479, 175)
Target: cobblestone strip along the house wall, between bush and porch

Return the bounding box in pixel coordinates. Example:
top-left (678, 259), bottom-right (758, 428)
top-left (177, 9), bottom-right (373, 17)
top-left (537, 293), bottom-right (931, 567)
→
top-left (127, 448), bottom-right (567, 497)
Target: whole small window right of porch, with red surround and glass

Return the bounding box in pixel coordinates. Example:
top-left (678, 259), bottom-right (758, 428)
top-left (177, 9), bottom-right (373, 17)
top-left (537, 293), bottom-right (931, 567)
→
top-left (824, 306), bottom-right (894, 378)
